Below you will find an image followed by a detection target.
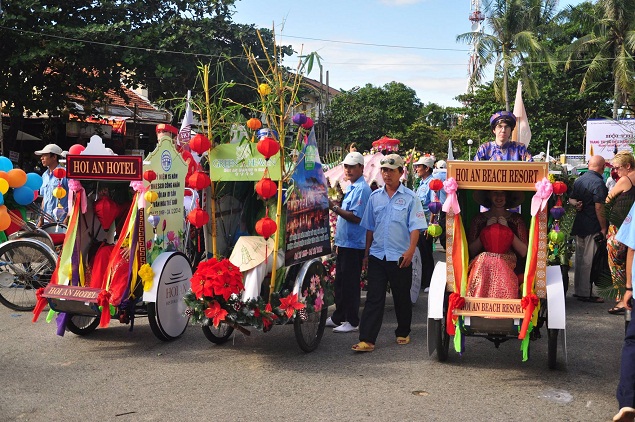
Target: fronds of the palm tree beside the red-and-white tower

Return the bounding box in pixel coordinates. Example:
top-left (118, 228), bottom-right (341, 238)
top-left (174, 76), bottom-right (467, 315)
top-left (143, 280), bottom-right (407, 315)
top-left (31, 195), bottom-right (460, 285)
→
top-left (456, 0), bottom-right (558, 111)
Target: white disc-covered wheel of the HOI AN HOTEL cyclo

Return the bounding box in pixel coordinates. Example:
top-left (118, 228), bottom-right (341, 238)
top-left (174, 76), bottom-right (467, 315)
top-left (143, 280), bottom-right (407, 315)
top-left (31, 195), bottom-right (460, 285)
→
top-left (143, 252), bottom-right (192, 341)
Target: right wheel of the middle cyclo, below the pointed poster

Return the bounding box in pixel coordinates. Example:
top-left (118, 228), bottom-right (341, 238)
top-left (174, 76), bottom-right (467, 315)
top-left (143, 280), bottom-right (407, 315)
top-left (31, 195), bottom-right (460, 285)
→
top-left (293, 259), bottom-right (328, 352)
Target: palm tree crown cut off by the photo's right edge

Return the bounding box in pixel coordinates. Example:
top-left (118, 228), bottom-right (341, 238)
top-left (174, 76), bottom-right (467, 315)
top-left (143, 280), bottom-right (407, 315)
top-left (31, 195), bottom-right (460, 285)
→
top-left (566, 0), bottom-right (635, 119)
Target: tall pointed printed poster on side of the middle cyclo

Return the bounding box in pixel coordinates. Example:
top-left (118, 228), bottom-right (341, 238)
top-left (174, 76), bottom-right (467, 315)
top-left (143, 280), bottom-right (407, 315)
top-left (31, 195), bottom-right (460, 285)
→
top-left (285, 130), bottom-right (331, 266)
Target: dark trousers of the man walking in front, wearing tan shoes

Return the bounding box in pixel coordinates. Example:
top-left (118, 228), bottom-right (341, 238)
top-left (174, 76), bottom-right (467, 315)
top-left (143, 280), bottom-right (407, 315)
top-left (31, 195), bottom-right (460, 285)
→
top-left (359, 255), bottom-right (412, 343)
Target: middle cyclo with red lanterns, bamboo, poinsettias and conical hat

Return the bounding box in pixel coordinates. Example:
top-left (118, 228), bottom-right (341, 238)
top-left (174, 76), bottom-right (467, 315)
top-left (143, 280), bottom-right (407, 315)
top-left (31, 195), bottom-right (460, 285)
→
top-left (185, 122), bottom-right (333, 352)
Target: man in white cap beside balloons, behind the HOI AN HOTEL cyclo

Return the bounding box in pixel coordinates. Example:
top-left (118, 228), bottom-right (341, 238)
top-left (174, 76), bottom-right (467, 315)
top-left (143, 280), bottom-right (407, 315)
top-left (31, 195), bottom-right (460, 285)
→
top-left (35, 144), bottom-right (68, 226)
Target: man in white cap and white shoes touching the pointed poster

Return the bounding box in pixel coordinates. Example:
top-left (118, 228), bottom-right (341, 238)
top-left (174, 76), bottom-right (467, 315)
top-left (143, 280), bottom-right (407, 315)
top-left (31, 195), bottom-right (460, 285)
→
top-left (326, 152), bottom-right (371, 333)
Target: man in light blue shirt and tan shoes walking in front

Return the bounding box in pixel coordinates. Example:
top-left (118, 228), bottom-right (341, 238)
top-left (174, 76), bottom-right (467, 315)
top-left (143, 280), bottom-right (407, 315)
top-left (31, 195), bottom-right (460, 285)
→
top-left (353, 154), bottom-right (427, 352)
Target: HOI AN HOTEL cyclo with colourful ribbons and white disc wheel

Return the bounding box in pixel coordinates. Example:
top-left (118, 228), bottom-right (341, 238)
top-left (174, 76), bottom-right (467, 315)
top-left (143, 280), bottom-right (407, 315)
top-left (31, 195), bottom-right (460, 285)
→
top-left (33, 125), bottom-right (192, 340)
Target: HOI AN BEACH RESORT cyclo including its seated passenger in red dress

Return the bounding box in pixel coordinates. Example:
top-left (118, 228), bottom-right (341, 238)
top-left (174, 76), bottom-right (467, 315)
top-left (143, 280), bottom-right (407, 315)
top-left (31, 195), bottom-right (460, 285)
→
top-left (428, 161), bottom-right (566, 368)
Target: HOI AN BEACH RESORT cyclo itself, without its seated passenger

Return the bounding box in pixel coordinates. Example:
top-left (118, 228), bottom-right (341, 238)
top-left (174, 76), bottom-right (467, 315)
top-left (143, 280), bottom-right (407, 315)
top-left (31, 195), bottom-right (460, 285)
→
top-left (428, 161), bottom-right (566, 368)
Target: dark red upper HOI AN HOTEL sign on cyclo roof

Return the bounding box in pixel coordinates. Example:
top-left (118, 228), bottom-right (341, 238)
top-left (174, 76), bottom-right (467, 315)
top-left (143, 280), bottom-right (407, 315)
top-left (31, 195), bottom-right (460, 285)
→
top-left (66, 155), bottom-right (143, 181)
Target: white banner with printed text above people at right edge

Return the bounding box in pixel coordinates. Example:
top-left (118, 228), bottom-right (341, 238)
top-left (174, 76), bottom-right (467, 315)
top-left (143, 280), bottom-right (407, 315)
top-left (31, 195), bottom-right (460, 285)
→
top-left (585, 119), bottom-right (635, 160)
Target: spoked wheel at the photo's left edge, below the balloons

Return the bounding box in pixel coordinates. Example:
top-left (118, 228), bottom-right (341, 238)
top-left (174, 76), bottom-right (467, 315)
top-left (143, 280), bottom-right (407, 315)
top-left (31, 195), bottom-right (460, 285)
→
top-left (0, 239), bottom-right (57, 312)
